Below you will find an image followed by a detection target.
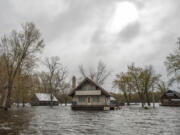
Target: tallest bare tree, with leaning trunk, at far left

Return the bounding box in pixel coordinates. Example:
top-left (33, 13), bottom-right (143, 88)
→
top-left (0, 23), bottom-right (44, 110)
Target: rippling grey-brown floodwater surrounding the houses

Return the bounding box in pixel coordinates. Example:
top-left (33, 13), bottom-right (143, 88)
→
top-left (0, 105), bottom-right (180, 135)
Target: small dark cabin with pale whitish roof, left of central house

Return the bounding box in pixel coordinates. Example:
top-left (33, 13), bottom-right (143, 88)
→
top-left (31, 93), bottom-right (59, 106)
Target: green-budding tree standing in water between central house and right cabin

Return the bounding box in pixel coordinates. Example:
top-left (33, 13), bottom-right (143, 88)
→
top-left (128, 64), bottom-right (160, 107)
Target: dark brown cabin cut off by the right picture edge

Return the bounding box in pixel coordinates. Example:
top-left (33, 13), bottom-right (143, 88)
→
top-left (161, 90), bottom-right (180, 106)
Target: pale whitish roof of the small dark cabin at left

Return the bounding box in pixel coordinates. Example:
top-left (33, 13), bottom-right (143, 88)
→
top-left (35, 93), bottom-right (58, 101)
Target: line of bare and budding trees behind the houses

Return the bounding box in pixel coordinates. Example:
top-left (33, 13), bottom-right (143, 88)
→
top-left (0, 22), bottom-right (180, 110)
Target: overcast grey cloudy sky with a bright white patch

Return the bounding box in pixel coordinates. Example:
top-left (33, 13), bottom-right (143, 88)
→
top-left (0, 0), bottom-right (180, 89)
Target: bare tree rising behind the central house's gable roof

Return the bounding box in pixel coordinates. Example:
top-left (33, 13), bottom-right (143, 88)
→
top-left (79, 61), bottom-right (111, 85)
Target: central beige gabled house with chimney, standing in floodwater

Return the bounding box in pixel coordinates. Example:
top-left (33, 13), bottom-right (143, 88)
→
top-left (69, 77), bottom-right (110, 110)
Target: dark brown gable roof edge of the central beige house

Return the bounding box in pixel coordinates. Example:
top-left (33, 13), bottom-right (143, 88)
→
top-left (68, 77), bottom-right (110, 96)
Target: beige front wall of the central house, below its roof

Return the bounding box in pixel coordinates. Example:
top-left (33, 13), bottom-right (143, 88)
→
top-left (72, 80), bottom-right (110, 110)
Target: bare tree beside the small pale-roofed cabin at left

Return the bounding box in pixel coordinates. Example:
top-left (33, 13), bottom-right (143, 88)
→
top-left (41, 57), bottom-right (69, 106)
